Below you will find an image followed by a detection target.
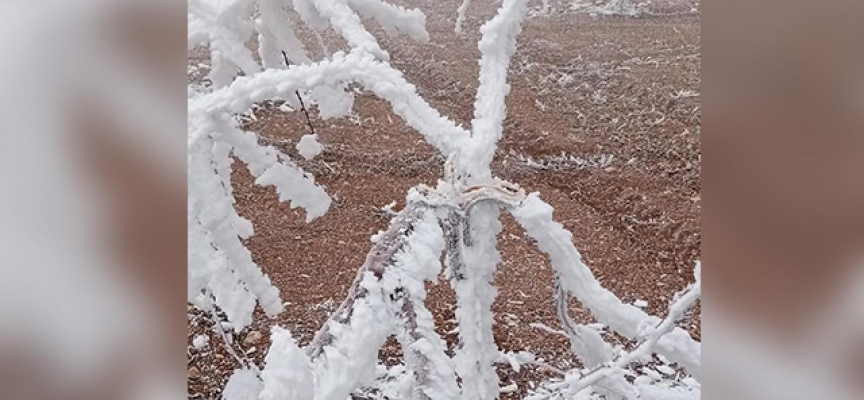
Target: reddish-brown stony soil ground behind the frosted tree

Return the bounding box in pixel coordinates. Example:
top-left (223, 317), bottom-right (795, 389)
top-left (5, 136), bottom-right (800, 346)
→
top-left (189, 0), bottom-right (701, 399)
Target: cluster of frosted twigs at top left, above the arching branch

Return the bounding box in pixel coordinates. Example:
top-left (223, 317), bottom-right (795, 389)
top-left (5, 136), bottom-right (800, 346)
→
top-left (187, 0), bottom-right (429, 88)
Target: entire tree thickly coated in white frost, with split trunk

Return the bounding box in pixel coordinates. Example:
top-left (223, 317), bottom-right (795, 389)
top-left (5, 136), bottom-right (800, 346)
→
top-left (188, 0), bottom-right (701, 400)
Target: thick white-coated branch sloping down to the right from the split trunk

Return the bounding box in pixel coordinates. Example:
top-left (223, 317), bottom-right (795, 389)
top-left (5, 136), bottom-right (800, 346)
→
top-left (512, 193), bottom-right (701, 379)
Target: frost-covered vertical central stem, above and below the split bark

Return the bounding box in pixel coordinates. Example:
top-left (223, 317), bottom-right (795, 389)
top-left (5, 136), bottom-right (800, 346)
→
top-left (438, 0), bottom-right (527, 400)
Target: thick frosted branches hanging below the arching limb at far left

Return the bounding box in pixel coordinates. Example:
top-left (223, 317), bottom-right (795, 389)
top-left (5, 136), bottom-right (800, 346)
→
top-left (187, 115), bottom-right (331, 330)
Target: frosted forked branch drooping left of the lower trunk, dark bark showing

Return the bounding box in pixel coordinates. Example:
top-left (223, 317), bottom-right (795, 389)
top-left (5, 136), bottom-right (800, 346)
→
top-left (306, 203), bottom-right (459, 400)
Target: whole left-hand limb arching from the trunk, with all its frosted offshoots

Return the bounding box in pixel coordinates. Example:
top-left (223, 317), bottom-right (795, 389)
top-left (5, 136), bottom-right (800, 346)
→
top-left (187, 0), bottom-right (460, 338)
